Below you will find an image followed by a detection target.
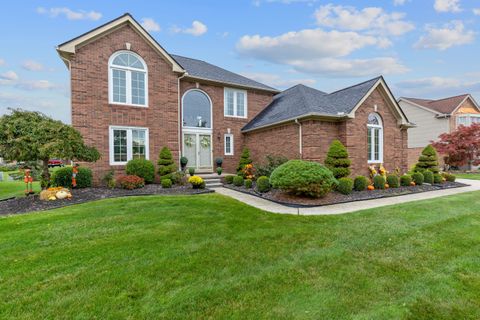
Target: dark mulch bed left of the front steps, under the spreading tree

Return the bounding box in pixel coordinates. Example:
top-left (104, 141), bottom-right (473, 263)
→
top-left (0, 184), bottom-right (214, 215)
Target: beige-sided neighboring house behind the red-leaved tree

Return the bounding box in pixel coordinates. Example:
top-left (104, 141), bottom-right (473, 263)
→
top-left (399, 94), bottom-right (480, 166)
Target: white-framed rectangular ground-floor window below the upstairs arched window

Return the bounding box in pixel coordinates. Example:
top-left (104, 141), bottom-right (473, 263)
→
top-left (109, 126), bottom-right (149, 165)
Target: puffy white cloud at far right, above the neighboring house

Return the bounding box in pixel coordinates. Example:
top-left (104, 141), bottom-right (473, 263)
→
top-left (414, 21), bottom-right (475, 50)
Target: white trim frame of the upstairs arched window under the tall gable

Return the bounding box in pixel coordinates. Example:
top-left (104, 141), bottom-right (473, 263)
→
top-left (108, 50), bottom-right (148, 108)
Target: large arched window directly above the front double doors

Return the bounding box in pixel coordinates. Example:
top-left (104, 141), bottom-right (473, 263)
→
top-left (182, 89), bottom-right (212, 129)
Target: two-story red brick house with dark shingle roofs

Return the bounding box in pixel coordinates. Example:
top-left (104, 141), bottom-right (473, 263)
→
top-left (57, 14), bottom-right (411, 182)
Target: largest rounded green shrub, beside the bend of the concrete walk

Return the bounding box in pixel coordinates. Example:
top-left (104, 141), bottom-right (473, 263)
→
top-left (270, 160), bottom-right (338, 198)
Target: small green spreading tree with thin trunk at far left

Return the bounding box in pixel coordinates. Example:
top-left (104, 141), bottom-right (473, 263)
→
top-left (0, 109), bottom-right (100, 187)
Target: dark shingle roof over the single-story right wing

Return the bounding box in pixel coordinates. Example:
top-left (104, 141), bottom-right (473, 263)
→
top-left (242, 77), bottom-right (381, 131)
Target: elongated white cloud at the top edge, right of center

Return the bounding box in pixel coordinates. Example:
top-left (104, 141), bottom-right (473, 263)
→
top-left (315, 4), bottom-right (415, 36)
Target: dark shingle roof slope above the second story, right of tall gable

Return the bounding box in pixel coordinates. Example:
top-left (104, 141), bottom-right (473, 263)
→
top-left (170, 54), bottom-right (279, 92)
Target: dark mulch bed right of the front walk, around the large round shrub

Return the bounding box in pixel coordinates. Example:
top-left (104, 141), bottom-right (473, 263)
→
top-left (224, 182), bottom-right (468, 208)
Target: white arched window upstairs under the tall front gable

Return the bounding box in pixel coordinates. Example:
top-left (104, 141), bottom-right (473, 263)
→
top-left (108, 51), bottom-right (148, 107)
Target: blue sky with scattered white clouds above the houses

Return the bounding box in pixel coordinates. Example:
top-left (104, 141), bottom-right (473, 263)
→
top-left (0, 0), bottom-right (480, 123)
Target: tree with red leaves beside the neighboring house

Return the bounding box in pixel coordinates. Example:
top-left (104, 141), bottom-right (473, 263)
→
top-left (432, 123), bottom-right (480, 170)
